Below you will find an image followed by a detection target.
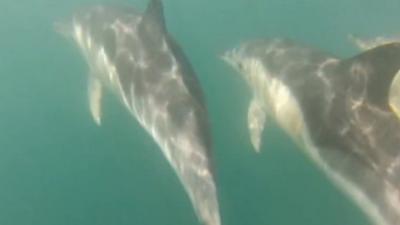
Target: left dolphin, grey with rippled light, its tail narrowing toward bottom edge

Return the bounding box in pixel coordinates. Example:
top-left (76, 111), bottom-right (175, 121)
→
top-left (57, 0), bottom-right (220, 225)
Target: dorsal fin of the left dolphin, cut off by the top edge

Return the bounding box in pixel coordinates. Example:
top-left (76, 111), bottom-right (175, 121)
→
top-left (142, 0), bottom-right (166, 32)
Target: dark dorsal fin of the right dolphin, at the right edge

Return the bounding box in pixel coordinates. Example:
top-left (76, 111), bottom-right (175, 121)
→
top-left (342, 42), bottom-right (400, 108)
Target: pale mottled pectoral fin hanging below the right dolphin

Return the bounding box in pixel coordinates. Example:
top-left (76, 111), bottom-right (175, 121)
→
top-left (247, 98), bottom-right (266, 152)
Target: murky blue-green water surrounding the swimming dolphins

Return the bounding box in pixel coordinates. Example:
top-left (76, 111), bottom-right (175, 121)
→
top-left (0, 0), bottom-right (400, 225)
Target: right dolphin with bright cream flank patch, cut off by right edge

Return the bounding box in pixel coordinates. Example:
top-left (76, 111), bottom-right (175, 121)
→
top-left (222, 39), bottom-right (400, 225)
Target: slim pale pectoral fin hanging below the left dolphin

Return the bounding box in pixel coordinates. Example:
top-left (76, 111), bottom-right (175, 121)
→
top-left (88, 75), bottom-right (102, 126)
